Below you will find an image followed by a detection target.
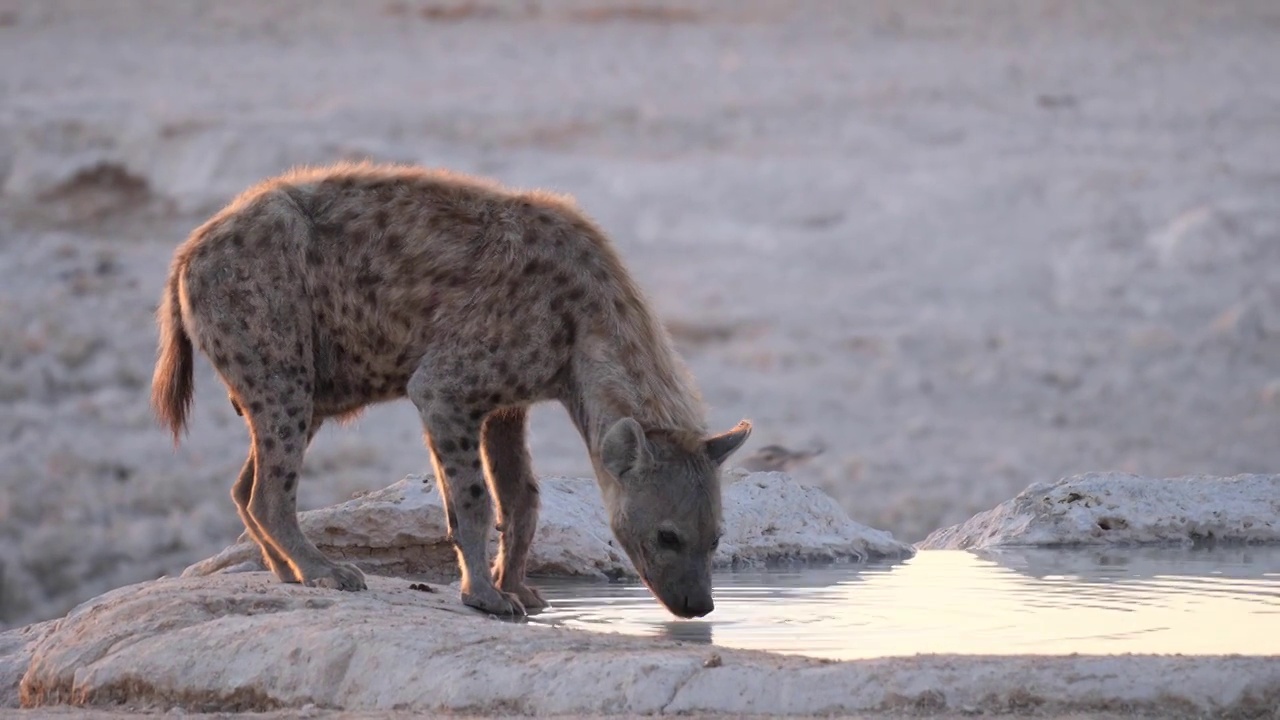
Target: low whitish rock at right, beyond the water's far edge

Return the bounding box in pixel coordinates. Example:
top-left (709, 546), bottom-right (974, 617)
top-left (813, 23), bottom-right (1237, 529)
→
top-left (916, 473), bottom-right (1280, 550)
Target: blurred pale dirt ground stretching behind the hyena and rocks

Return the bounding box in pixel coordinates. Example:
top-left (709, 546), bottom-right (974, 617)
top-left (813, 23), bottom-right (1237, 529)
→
top-left (0, 0), bottom-right (1280, 628)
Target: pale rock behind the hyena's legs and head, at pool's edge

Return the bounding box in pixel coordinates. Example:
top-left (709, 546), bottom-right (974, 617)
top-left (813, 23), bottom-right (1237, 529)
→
top-left (183, 473), bottom-right (915, 579)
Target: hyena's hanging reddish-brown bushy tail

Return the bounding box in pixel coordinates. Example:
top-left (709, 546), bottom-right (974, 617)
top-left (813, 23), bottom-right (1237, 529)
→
top-left (151, 266), bottom-right (195, 445)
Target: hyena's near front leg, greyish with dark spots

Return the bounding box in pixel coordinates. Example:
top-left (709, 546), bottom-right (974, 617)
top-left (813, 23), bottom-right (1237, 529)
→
top-left (408, 363), bottom-right (525, 615)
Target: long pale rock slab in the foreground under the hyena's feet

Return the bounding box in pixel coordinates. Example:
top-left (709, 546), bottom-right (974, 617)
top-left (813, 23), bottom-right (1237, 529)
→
top-left (19, 573), bottom-right (1280, 717)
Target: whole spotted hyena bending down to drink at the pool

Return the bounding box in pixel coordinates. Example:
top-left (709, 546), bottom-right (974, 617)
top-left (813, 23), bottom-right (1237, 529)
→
top-left (152, 165), bottom-right (750, 616)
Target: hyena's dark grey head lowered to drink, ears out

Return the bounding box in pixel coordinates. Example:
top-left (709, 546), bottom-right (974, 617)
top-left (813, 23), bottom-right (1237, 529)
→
top-left (598, 418), bottom-right (751, 618)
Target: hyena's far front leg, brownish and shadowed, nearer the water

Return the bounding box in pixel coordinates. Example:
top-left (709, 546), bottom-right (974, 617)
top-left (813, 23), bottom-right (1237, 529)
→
top-left (481, 407), bottom-right (548, 610)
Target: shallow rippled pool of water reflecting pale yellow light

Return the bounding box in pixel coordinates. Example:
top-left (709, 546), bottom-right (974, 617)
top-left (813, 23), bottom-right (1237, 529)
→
top-left (531, 547), bottom-right (1280, 660)
